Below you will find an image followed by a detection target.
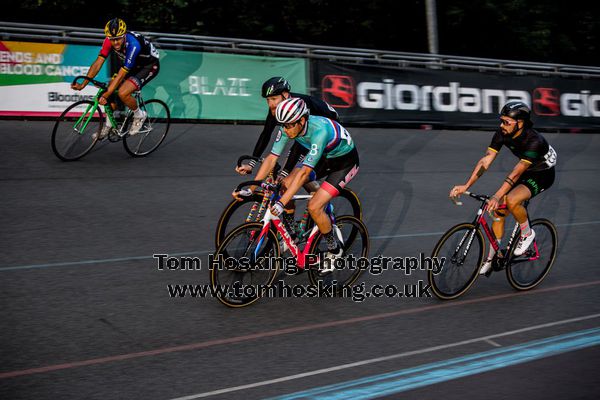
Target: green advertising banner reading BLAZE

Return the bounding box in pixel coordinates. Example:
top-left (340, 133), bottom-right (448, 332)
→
top-left (143, 50), bottom-right (307, 121)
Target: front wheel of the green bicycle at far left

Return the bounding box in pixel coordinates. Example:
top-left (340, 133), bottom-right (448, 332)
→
top-left (52, 100), bottom-right (104, 161)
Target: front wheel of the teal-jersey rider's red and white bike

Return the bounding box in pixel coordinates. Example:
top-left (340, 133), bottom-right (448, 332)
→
top-left (210, 222), bottom-right (281, 307)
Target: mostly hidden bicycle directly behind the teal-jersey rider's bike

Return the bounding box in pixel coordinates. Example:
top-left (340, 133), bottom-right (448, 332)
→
top-left (215, 155), bottom-right (362, 248)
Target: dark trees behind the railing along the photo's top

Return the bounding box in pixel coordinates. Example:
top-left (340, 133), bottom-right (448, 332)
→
top-left (5, 0), bottom-right (600, 65)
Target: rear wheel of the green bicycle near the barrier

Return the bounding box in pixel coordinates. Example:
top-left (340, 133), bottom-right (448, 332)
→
top-left (123, 99), bottom-right (171, 157)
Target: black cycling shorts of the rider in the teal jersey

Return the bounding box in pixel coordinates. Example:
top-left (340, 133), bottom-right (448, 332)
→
top-left (315, 148), bottom-right (359, 197)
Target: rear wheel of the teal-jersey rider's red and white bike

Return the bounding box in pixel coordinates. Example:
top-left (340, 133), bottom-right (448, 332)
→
top-left (307, 215), bottom-right (370, 295)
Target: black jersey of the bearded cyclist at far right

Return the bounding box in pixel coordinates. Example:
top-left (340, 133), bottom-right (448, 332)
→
top-left (489, 128), bottom-right (556, 171)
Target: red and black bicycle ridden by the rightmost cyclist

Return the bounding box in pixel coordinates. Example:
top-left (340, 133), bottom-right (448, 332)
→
top-left (428, 192), bottom-right (558, 300)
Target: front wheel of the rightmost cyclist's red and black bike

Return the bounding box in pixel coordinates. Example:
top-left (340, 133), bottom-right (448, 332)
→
top-left (428, 223), bottom-right (484, 300)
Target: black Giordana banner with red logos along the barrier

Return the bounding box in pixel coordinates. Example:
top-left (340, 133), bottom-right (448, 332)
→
top-left (312, 61), bottom-right (600, 129)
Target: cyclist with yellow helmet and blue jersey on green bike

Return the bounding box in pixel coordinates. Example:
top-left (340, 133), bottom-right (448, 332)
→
top-left (71, 18), bottom-right (160, 139)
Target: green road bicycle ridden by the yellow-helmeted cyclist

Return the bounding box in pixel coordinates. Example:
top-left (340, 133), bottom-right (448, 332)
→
top-left (52, 75), bottom-right (171, 161)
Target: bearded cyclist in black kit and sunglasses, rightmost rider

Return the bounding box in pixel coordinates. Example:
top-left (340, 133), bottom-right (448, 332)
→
top-left (450, 101), bottom-right (556, 274)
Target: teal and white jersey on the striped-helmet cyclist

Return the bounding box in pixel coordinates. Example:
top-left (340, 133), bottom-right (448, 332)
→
top-left (271, 115), bottom-right (354, 168)
